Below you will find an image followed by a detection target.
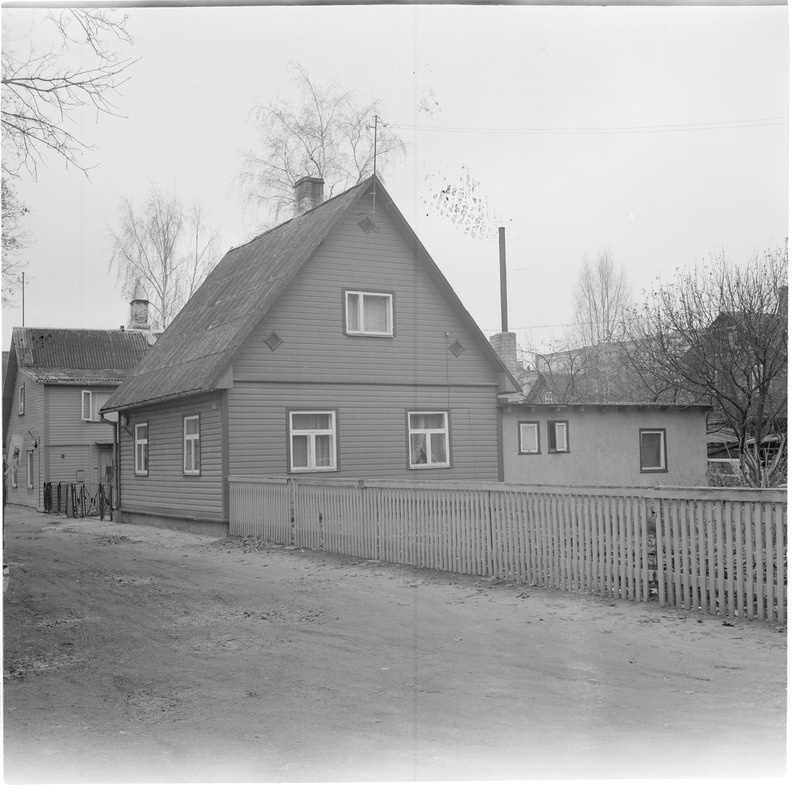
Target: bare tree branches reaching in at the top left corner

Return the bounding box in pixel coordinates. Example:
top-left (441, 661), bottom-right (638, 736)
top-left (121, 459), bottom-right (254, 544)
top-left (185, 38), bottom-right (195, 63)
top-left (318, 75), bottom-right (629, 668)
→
top-left (2, 8), bottom-right (134, 177)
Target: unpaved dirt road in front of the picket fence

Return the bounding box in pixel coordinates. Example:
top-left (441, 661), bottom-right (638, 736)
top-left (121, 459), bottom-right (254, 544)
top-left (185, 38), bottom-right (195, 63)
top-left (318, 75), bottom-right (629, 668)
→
top-left (3, 508), bottom-right (786, 783)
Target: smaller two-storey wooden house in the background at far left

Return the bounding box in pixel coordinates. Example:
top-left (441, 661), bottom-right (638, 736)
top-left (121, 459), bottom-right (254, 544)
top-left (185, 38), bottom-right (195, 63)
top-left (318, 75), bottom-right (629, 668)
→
top-left (3, 301), bottom-right (152, 508)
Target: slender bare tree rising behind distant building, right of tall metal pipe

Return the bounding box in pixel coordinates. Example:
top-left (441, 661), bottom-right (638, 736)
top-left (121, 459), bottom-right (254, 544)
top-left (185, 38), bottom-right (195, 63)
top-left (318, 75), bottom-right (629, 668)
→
top-left (575, 251), bottom-right (630, 346)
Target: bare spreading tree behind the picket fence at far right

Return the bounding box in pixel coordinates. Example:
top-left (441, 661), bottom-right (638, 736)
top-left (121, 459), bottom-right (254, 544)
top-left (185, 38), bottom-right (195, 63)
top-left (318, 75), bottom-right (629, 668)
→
top-left (627, 246), bottom-right (788, 487)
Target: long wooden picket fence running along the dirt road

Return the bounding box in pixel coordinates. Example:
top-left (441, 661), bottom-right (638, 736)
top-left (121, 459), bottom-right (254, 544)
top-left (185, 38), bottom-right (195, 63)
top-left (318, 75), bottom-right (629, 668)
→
top-left (229, 477), bottom-right (787, 622)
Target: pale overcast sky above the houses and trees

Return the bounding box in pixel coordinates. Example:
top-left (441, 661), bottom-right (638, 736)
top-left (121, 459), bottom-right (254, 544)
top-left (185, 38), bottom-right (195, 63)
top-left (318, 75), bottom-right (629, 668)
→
top-left (2, 5), bottom-right (789, 348)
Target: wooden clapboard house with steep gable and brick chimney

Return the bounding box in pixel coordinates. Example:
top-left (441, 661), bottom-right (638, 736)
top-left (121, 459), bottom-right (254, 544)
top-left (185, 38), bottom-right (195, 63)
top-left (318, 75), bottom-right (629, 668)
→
top-left (98, 177), bottom-right (518, 534)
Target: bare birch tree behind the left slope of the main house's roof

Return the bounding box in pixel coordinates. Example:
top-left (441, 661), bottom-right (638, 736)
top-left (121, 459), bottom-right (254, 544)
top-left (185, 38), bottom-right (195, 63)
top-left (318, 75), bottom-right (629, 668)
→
top-left (109, 187), bottom-right (217, 329)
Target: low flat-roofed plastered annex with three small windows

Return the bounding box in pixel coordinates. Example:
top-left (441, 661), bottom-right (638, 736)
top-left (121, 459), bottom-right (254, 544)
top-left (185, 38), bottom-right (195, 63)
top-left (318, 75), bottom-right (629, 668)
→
top-left (493, 332), bottom-right (711, 486)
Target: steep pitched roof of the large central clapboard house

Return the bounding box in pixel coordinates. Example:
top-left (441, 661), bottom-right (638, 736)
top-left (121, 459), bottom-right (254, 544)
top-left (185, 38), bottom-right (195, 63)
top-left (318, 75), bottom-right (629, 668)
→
top-left (105, 177), bottom-right (516, 410)
